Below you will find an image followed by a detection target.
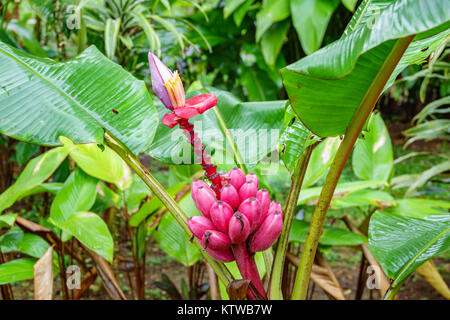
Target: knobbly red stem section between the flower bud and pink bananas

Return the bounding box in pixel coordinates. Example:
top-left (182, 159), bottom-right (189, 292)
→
top-left (178, 119), bottom-right (222, 198)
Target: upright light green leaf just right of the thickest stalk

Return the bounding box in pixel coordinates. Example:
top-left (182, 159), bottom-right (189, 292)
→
top-left (352, 113), bottom-right (394, 181)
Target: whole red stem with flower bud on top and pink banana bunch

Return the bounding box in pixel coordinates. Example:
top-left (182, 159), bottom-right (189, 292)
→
top-left (148, 52), bottom-right (283, 299)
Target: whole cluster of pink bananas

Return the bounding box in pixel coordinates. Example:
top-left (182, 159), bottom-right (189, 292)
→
top-left (188, 168), bottom-right (283, 262)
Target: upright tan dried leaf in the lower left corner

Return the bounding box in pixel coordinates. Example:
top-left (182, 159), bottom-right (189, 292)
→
top-left (33, 246), bottom-right (53, 300)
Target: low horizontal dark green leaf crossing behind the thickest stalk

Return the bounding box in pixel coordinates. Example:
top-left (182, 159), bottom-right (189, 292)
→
top-left (289, 219), bottom-right (367, 246)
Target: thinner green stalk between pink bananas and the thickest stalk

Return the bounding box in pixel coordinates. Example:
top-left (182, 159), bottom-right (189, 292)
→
top-left (268, 145), bottom-right (314, 300)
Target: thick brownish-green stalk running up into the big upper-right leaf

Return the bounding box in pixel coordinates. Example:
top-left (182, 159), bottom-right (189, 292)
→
top-left (291, 35), bottom-right (414, 300)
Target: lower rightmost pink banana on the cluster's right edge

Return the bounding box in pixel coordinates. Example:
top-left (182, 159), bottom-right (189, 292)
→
top-left (249, 211), bottom-right (283, 252)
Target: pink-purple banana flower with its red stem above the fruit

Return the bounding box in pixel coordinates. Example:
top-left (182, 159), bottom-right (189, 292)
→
top-left (148, 52), bottom-right (222, 196)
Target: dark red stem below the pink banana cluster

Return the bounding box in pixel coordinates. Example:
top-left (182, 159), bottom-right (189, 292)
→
top-left (231, 242), bottom-right (267, 300)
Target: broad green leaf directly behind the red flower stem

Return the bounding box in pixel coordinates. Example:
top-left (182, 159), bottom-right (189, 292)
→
top-left (149, 88), bottom-right (286, 168)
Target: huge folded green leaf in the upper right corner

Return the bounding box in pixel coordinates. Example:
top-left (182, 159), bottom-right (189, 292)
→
top-left (281, 0), bottom-right (450, 137)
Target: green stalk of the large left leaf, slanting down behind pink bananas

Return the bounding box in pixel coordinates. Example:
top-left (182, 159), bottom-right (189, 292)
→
top-left (104, 131), bottom-right (233, 286)
